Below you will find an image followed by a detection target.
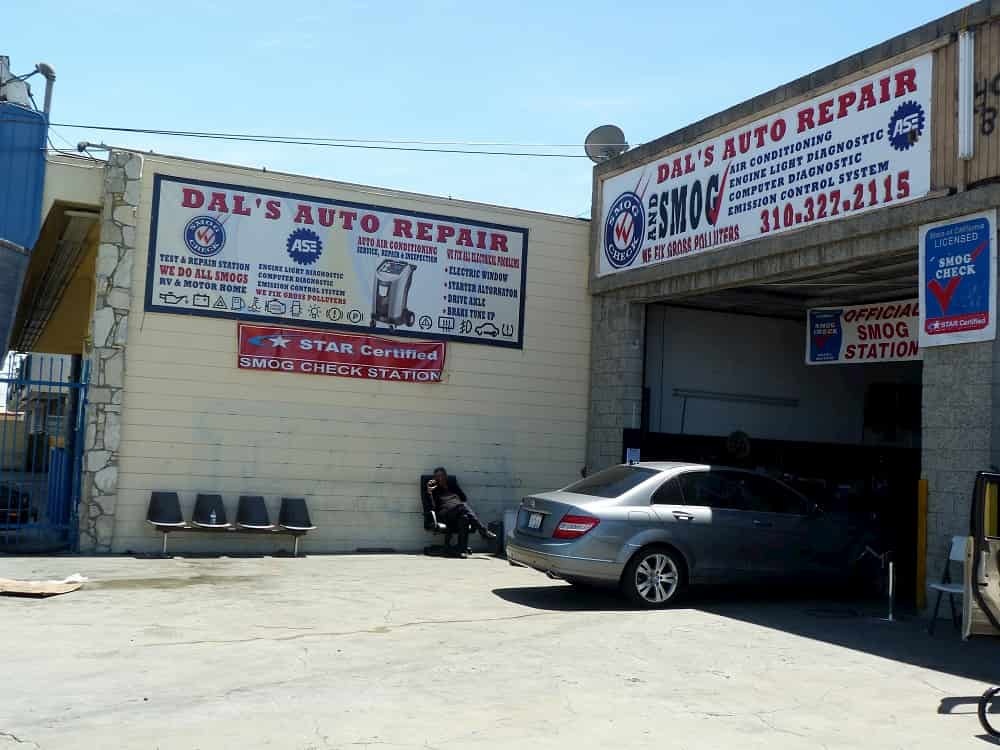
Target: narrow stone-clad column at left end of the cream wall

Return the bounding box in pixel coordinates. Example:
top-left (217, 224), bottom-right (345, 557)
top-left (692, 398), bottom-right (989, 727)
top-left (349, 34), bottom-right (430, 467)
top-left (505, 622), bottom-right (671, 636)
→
top-left (80, 151), bottom-right (142, 552)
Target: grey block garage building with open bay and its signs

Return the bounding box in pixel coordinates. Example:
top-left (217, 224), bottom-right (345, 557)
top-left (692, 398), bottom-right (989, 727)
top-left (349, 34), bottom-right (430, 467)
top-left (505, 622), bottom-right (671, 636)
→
top-left (588, 2), bottom-right (1000, 608)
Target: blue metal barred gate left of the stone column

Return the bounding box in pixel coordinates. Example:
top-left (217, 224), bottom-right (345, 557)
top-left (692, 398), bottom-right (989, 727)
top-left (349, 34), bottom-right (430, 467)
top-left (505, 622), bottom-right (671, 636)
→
top-left (0, 354), bottom-right (89, 553)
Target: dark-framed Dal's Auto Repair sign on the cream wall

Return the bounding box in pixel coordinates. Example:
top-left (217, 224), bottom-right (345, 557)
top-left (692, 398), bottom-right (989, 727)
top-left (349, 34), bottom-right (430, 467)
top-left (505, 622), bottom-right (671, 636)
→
top-left (146, 175), bottom-right (528, 348)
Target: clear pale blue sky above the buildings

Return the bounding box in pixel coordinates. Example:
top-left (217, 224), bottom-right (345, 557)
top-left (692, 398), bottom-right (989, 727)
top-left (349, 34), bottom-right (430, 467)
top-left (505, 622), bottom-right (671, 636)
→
top-left (0, 0), bottom-right (965, 216)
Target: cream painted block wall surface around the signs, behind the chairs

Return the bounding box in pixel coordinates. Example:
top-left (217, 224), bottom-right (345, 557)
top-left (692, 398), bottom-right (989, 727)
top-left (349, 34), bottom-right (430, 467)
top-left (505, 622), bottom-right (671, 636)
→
top-left (112, 156), bottom-right (590, 552)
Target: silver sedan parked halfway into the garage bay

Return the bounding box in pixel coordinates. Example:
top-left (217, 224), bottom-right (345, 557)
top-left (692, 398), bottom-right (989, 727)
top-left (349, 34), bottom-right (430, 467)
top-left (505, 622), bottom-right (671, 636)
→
top-left (507, 463), bottom-right (863, 607)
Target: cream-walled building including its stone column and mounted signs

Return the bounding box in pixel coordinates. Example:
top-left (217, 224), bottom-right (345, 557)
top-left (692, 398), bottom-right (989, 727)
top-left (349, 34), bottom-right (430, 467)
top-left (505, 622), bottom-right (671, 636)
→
top-left (8, 151), bottom-right (590, 553)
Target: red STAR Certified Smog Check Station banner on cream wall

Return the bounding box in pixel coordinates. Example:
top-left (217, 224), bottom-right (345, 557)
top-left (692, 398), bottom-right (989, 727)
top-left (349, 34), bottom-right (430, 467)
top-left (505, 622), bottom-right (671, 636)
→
top-left (237, 323), bottom-right (445, 383)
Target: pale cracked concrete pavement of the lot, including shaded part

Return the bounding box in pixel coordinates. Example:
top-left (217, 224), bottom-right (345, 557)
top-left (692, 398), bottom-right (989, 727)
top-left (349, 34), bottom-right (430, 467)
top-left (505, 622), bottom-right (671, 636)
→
top-left (0, 555), bottom-right (1000, 750)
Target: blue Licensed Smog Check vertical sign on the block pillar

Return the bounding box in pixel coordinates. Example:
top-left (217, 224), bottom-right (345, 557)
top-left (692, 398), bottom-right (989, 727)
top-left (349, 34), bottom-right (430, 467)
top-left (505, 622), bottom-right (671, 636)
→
top-left (920, 210), bottom-right (997, 346)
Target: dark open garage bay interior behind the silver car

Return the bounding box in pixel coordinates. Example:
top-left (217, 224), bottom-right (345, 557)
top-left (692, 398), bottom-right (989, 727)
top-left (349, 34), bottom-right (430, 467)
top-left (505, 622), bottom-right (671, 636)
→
top-left (623, 248), bottom-right (922, 607)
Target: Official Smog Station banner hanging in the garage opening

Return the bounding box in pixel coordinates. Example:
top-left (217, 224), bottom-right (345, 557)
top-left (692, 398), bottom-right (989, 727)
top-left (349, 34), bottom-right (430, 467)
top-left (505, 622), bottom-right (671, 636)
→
top-left (806, 299), bottom-right (921, 365)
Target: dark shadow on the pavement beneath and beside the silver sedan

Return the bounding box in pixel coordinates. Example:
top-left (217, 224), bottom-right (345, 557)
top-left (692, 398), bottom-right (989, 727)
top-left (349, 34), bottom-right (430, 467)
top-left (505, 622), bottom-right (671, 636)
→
top-left (493, 584), bottom-right (1000, 684)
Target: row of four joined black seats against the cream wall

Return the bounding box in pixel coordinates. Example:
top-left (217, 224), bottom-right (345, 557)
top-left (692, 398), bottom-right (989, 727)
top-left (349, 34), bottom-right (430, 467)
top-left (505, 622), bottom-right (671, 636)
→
top-left (146, 492), bottom-right (316, 557)
